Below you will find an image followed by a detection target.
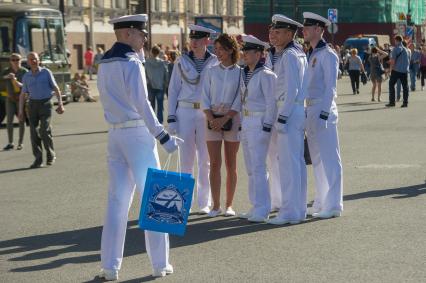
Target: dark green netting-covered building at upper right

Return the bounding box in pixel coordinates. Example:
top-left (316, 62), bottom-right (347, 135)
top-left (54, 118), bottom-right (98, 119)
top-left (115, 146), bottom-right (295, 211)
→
top-left (244, 0), bottom-right (426, 44)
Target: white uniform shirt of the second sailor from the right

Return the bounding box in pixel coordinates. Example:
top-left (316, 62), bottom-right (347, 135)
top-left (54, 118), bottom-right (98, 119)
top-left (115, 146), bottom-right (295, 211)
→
top-left (266, 42), bottom-right (308, 117)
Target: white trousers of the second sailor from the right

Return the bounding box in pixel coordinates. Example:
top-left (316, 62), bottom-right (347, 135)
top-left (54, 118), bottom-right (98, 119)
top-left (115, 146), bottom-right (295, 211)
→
top-left (278, 105), bottom-right (307, 220)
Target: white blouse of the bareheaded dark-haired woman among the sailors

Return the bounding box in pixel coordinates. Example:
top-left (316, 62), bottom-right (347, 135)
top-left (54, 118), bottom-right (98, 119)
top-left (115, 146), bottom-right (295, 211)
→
top-left (201, 64), bottom-right (242, 114)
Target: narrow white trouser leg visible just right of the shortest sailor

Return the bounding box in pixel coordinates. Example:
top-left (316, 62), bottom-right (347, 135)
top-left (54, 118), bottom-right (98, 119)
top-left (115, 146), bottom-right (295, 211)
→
top-left (267, 127), bottom-right (283, 210)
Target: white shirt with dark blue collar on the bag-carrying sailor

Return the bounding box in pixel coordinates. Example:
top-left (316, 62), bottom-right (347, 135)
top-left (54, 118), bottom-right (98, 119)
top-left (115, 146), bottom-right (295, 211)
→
top-left (97, 42), bottom-right (164, 137)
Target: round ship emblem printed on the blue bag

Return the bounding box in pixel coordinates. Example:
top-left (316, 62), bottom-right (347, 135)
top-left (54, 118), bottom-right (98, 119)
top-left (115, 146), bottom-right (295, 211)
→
top-left (147, 185), bottom-right (188, 224)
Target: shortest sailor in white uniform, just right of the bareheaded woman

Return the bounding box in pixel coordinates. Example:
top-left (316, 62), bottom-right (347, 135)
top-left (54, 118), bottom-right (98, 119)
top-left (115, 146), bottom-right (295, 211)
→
top-left (239, 35), bottom-right (277, 222)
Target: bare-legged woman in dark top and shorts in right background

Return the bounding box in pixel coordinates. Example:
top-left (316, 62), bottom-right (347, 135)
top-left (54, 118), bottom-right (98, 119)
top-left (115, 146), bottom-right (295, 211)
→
top-left (369, 47), bottom-right (388, 102)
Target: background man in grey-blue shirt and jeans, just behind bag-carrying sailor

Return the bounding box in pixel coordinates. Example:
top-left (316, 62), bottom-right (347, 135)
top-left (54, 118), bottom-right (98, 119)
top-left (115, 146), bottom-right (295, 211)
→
top-left (145, 45), bottom-right (169, 123)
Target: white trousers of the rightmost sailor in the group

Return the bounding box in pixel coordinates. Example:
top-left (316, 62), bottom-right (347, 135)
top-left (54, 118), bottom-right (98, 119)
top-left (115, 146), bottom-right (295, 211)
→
top-left (306, 102), bottom-right (343, 211)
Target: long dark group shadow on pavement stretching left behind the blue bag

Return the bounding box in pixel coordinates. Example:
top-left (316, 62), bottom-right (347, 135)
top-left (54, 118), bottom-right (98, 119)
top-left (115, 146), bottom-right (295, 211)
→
top-left (0, 217), bottom-right (316, 272)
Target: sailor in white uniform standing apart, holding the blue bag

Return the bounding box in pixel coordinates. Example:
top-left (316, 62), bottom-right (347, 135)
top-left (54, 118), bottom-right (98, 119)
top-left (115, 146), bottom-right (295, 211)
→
top-left (97, 14), bottom-right (182, 280)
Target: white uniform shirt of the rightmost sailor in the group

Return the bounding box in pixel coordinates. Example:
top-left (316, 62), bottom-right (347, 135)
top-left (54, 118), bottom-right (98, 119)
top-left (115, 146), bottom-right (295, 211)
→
top-left (302, 40), bottom-right (339, 113)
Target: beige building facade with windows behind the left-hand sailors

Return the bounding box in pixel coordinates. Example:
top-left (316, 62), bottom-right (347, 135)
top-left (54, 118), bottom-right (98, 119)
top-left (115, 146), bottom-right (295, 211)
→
top-left (0, 0), bottom-right (244, 72)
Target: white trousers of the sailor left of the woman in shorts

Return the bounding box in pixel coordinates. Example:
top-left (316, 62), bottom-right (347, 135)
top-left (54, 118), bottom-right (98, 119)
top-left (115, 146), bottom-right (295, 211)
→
top-left (176, 107), bottom-right (211, 208)
